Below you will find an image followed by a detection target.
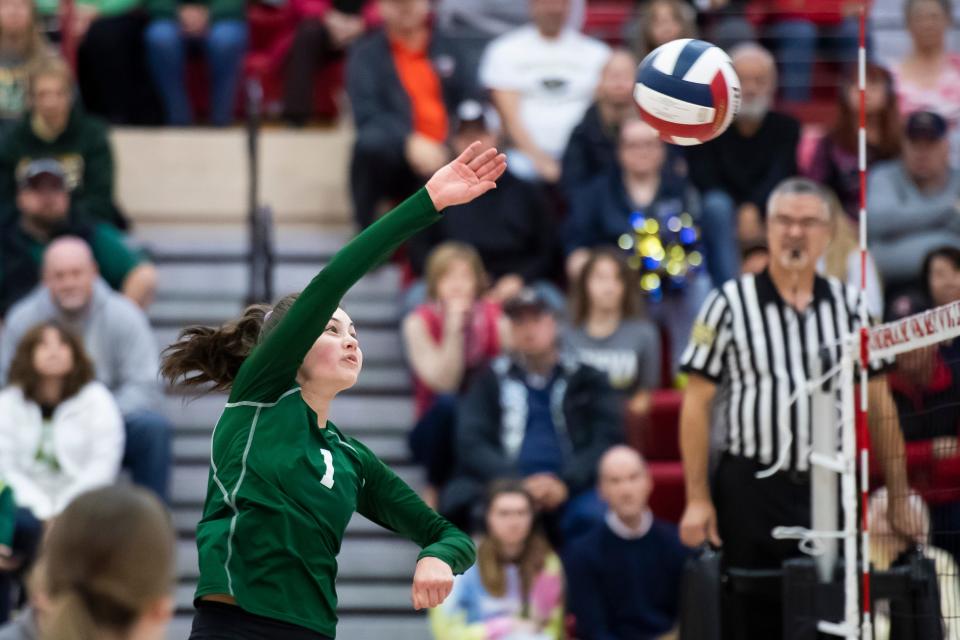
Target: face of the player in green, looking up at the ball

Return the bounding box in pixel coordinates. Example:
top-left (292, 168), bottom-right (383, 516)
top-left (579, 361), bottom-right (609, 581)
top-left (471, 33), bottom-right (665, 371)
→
top-left (297, 309), bottom-right (363, 393)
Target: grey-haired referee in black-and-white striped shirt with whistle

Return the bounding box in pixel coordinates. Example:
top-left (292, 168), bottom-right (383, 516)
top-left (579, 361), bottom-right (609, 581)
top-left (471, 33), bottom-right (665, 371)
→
top-left (680, 178), bottom-right (911, 640)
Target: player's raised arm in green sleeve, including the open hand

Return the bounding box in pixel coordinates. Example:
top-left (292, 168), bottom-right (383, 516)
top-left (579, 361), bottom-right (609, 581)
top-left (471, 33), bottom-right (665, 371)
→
top-left (230, 148), bottom-right (506, 402)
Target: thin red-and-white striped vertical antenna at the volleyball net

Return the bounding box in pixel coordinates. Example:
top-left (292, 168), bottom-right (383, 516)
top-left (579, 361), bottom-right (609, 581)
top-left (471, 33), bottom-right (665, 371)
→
top-left (860, 0), bottom-right (873, 640)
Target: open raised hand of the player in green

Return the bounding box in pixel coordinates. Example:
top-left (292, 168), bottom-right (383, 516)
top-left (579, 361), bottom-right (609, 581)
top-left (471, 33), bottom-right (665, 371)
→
top-left (427, 142), bottom-right (507, 211)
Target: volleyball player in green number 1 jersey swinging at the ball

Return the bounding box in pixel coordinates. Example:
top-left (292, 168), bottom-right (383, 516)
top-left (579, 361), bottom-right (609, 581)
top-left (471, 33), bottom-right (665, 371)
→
top-left (162, 143), bottom-right (506, 640)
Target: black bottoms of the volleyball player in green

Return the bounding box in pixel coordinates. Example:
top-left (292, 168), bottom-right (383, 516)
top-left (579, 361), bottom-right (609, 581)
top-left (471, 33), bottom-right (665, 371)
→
top-left (188, 600), bottom-right (331, 640)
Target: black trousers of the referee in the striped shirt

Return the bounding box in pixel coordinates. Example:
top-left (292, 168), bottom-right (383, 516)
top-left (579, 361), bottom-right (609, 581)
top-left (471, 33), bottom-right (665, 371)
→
top-left (713, 455), bottom-right (810, 640)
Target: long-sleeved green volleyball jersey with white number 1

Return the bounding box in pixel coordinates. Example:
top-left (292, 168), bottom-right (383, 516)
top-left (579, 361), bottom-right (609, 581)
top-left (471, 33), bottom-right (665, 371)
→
top-left (196, 189), bottom-right (475, 637)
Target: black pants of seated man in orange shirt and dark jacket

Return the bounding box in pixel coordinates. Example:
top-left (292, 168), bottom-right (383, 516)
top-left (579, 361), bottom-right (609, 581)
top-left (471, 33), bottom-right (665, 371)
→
top-left (350, 139), bottom-right (418, 229)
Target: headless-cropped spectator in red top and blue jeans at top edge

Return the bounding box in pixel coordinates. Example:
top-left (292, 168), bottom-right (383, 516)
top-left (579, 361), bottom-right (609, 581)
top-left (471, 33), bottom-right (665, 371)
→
top-left (747, 0), bottom-right (861, 102)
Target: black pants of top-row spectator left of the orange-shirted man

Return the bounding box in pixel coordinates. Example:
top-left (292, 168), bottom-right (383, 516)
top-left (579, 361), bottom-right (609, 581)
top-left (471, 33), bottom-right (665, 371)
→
top-left (283, 18), bottom-right (343, 125)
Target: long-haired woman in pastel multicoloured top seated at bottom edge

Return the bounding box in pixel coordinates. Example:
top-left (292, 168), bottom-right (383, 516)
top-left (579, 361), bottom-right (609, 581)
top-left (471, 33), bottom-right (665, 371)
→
top-left (430, 480), bottom-right (565, 640)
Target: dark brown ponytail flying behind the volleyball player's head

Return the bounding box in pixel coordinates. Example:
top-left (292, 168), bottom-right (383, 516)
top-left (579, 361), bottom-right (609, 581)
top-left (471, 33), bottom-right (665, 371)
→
top-left (160, 294), bottom-right (297, 391)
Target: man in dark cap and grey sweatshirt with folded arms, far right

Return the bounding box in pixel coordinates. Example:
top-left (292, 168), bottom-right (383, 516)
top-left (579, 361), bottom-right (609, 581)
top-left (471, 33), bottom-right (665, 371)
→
top-left (867, 111), bottom-right (960, 295)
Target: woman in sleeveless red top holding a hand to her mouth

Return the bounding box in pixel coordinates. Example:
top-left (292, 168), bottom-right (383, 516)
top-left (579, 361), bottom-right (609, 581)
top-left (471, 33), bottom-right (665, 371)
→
top-left (403, 242), bottom-right (508, 505)
